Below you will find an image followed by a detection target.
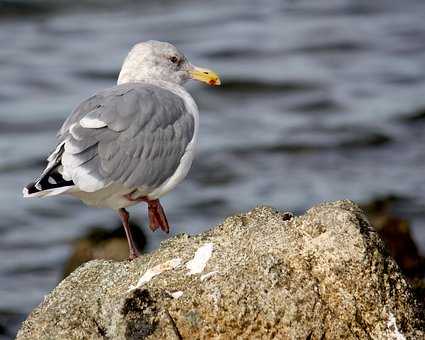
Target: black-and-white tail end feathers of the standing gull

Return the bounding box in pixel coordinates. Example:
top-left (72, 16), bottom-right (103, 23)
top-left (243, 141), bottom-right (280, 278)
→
top-left (22, 145), bottom-right (74, 197)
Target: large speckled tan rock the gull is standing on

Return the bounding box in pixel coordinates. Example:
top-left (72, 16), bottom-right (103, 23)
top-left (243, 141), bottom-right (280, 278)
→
top-left (18, 201), bottom-right (425, 340)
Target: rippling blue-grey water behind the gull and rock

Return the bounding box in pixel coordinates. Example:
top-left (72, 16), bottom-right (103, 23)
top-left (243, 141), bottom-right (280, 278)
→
top-left (0, 0), bottom-right (425, 338)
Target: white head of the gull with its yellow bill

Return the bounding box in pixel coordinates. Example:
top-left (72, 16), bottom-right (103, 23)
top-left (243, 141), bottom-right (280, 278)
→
top-left (118, 40), bottom-right (220, 85)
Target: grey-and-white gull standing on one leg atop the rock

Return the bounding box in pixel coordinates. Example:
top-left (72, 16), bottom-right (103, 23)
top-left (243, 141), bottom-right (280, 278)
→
top-left (23, 40), bottom-right (220, 260)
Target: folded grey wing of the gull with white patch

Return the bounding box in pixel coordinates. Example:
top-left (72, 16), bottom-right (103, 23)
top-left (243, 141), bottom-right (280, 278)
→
top-left (58, 83), bottom-right (195, 191)
